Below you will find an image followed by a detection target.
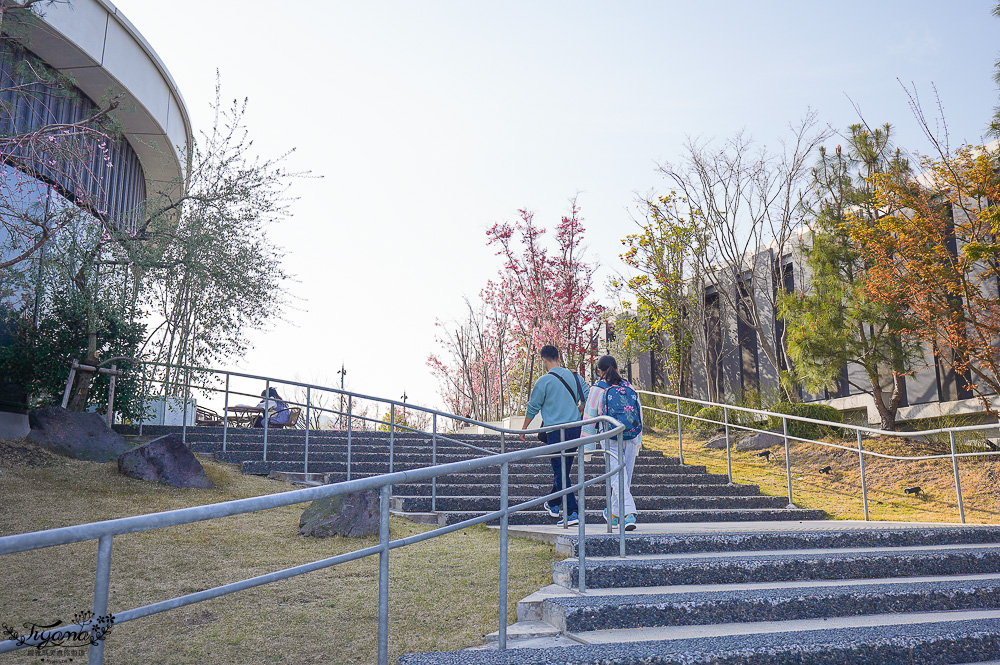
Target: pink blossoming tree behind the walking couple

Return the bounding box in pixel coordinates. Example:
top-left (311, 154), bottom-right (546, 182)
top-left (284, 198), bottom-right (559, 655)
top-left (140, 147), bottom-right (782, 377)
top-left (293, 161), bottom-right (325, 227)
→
top-left (428, 198), bottom-right (604, 420)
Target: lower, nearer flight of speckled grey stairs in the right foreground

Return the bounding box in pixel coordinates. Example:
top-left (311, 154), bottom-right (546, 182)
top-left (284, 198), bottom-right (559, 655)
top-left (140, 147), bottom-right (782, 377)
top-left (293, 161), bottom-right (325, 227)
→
top-left (399, 522), bottom-right (1000, 665)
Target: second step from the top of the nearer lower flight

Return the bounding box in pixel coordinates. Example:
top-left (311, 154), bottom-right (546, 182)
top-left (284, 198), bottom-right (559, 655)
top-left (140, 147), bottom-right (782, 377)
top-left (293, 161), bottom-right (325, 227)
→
top-left (552, 544), bottom-right (1000, 588)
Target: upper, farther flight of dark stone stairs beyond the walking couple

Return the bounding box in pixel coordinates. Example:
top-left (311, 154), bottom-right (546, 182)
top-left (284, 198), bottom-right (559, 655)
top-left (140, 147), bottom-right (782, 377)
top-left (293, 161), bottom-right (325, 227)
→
top-left (113, 426), bottom-right (824, 525)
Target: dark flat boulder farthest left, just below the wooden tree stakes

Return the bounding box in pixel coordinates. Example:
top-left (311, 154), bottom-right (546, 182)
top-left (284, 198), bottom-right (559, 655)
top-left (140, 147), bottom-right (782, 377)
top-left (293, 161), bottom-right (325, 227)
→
top-left (28, 406), bottom-right (129, 462)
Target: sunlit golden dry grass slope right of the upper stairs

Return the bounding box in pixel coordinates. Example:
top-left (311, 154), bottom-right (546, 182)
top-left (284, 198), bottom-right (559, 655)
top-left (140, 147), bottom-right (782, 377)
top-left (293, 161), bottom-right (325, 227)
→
top-left (642, 432), bottom-right (1000, 524)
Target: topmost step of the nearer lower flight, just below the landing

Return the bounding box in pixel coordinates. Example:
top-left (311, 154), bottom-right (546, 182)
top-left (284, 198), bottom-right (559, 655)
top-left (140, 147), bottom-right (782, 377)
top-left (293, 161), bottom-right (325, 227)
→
top-left (556, 525), bottom-right (1000, 557)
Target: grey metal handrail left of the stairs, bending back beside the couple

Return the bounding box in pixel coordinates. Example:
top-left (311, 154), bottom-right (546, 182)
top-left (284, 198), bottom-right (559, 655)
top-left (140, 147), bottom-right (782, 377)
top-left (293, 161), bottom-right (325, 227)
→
top-left (0, 370), bottom-right (625, 665)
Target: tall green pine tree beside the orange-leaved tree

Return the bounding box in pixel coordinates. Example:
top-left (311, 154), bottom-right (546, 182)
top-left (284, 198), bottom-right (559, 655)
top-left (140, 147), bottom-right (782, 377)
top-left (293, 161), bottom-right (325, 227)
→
top-left (780, 124), bottom-right (921, 430)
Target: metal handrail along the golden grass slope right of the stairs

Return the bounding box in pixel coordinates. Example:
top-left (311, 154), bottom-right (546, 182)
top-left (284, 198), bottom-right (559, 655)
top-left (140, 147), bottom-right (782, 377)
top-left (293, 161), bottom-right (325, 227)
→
top-left (636, 390), bottom-right (1000, 524)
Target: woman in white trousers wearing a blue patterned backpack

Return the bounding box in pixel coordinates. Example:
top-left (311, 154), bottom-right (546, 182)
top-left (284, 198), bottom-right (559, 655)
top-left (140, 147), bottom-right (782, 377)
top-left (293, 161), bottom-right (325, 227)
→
top-left (583, 356), bottom-right (642, 531)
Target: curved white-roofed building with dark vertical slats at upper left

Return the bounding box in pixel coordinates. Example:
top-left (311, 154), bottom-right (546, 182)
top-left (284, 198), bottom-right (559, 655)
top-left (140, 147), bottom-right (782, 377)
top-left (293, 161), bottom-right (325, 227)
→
top-left (0, 0), bottom-right (192, 438)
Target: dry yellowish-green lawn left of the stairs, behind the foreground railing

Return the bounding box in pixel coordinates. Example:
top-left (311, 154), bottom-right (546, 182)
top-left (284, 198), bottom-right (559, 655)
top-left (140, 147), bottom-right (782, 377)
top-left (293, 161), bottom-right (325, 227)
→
top-left (0, 441), bottom-right (561, 665)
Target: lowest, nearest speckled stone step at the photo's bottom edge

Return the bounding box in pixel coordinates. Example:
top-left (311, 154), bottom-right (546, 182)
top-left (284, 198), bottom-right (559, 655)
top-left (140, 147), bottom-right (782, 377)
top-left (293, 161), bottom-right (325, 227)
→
top-left (397, 610), bottom-right (1000, 665)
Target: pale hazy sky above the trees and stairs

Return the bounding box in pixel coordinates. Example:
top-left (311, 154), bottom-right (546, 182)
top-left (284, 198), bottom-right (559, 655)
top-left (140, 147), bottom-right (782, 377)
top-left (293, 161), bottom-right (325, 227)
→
top-left (107, 0), bottom-right (1000, 406)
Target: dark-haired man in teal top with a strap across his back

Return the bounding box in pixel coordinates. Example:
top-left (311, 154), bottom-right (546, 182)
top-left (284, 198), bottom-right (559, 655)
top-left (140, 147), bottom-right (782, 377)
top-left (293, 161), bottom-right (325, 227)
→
top-left (521, 345), bottom-right (590, 526)
